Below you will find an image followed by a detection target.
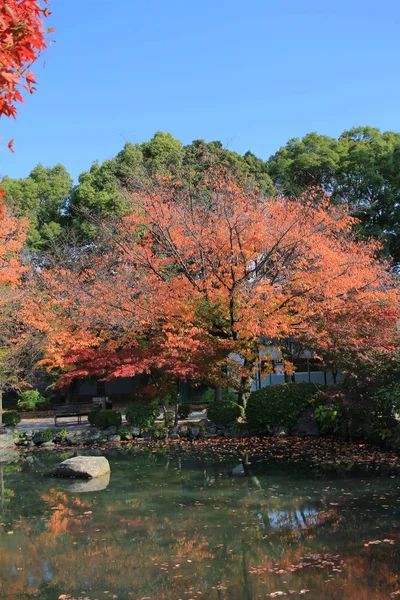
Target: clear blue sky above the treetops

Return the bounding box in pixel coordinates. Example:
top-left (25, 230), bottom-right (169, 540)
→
top-left (0, 0), bottom-right (400, 179)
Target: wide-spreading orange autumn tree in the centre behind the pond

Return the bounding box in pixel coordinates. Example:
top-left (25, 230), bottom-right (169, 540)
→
top-left (32, 170), bottom-right (395, 403)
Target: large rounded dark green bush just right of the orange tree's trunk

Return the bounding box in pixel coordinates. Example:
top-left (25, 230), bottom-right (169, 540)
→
top-left (246, 383), bottom-right (321, 433)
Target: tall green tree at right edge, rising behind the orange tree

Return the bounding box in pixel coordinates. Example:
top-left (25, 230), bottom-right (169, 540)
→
top-left (269, 127), bottom-right (400, 263)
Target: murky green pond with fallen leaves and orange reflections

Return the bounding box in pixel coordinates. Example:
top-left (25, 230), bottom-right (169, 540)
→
top-left (0, 445), bottom-right (400, 600)
